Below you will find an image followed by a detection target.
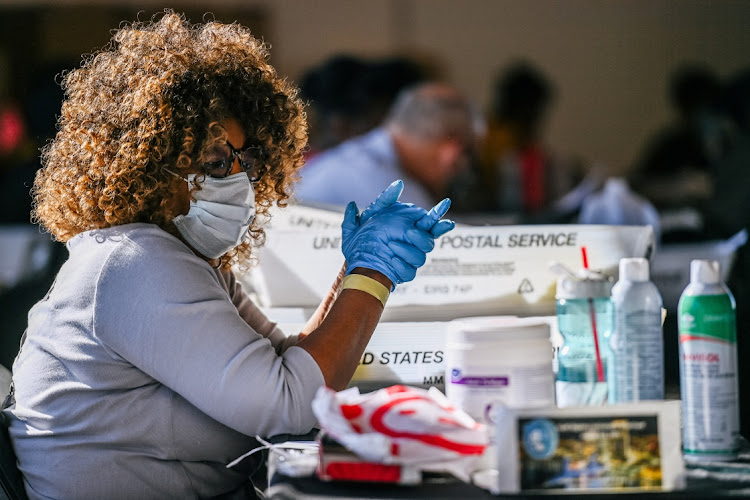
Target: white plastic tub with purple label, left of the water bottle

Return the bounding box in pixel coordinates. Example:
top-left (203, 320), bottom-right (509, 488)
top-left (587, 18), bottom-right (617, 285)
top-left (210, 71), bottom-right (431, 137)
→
top-left (445, 316), bottom-right (555, 422)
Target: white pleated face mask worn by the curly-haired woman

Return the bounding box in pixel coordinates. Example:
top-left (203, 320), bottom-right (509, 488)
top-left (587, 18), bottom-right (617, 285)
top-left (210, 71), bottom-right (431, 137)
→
top-left (172, 172), bottom-right (255, 259)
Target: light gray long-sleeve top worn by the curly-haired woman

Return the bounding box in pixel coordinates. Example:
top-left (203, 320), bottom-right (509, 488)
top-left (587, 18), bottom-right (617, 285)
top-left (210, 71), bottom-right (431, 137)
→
top-left (6, 224), bottom-right (324, 498)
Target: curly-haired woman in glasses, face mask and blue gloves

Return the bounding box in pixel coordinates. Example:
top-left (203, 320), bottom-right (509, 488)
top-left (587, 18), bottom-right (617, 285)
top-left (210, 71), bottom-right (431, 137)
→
top-left (4, 11), bottom-right (453, 498)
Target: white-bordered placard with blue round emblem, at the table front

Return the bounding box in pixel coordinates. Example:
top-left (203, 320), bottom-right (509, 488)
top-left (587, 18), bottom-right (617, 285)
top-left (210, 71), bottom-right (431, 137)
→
top-left (492, 401), bottom-right (685, 494)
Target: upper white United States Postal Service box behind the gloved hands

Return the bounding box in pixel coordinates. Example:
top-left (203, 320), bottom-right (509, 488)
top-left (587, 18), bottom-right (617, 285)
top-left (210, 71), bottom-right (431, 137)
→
top-left (241, 203), bottom-right (654, 321)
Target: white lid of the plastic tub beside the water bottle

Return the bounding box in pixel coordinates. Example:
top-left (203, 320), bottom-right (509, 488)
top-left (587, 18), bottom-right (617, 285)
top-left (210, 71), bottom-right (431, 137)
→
top-left (446, 316), bottom-right (550, 342)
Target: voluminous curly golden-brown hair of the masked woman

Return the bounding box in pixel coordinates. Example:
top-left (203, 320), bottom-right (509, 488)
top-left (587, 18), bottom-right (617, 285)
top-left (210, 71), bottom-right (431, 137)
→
top-left (32, 10), bottom-right (307, 267)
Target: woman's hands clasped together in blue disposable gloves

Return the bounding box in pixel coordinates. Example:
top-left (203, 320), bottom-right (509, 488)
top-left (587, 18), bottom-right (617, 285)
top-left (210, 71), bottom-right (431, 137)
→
top-left (341, 181), bottom-right (455, 290)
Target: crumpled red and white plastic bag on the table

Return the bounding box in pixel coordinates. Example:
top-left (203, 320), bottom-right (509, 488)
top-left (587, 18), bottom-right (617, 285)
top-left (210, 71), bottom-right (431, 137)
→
top-left (312, 385), bottom-right (490, 482)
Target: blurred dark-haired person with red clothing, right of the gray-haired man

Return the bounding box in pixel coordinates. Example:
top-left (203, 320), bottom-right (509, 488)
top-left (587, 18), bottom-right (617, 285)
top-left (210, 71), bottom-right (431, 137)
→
top-left (479, 61), bottom-right (583, 218)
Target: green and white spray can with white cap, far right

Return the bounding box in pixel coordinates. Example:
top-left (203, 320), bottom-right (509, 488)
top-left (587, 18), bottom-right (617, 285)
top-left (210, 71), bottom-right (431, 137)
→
top-left (678, 260), bottom-right (739, 461)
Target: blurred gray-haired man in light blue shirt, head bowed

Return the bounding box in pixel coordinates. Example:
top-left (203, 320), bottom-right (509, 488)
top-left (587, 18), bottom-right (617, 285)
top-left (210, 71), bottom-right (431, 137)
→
top-left (295, 82), bottom-right (481, 211)
